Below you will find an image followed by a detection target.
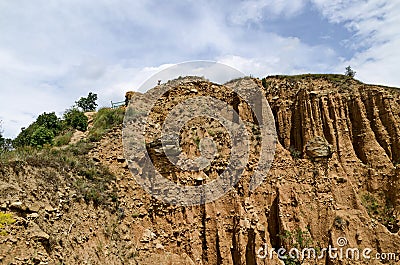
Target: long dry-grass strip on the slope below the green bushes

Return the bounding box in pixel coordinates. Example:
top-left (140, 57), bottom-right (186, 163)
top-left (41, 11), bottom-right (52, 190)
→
top-left (0, 141), bottom-right (117, 206)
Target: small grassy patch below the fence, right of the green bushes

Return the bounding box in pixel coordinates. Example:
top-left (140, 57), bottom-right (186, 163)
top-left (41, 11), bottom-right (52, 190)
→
top-left (89, 108), bottom-right (125, 142)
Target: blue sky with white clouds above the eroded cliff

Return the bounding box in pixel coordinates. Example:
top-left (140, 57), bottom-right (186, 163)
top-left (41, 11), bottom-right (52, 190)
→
top-left (0, 0), bottom-right (400, 137)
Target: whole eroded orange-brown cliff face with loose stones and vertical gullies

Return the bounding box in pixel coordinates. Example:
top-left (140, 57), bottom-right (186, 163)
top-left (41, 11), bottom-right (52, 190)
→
top-left (0, 75), bottom-right (400, 265)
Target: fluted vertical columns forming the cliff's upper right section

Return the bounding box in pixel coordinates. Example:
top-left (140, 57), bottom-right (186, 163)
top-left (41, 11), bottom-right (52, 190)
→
top-left (266, 77), bottom-right (400, 222)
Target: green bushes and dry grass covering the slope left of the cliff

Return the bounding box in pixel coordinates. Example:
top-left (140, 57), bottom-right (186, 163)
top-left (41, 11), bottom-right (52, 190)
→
top-left (0, 92), bottom-right (125, 209)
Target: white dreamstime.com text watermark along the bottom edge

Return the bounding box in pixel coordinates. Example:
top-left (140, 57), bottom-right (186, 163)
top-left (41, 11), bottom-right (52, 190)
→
top-left (257, 237), bottom-right (400, 262)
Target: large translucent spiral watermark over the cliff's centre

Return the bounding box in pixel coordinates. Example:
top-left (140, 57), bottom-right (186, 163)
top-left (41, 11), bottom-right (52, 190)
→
top-left (122, 61), bottom-right (276, 206)
